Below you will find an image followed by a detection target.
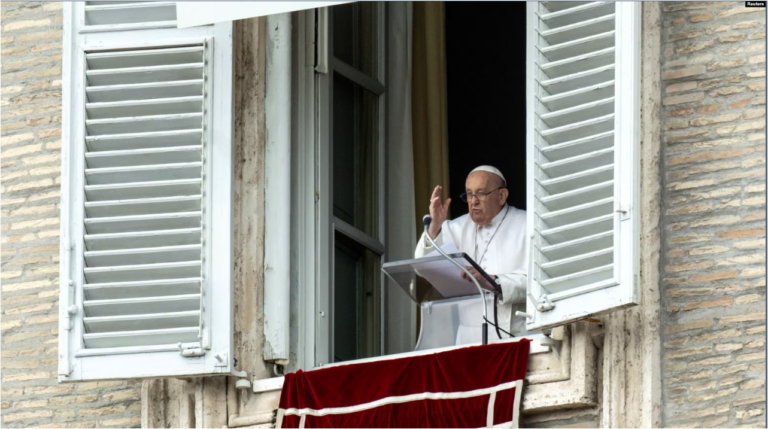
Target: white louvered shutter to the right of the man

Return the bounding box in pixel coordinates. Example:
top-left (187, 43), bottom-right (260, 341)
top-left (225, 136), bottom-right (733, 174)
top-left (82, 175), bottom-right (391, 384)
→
top-left (526, 1), bottom-right (640, 329)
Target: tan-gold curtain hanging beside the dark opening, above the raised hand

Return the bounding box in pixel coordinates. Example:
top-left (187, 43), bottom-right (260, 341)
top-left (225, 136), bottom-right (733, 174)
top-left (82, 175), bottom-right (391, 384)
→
top-left (411, 2), bottom-right (450, 237)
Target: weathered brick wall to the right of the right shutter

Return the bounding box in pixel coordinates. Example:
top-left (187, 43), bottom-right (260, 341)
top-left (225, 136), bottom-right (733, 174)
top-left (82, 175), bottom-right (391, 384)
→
top-left (661, 1), bottom-right (765, 429)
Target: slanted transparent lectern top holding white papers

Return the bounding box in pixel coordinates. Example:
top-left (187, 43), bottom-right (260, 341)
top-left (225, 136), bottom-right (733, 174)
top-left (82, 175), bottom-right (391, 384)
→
top-left (381, 243), bottom-right (496, 304)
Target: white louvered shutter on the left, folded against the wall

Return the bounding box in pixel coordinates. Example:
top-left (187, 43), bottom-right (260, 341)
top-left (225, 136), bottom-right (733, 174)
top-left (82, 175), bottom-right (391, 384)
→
top-left (59, 2), bottom-right (233, 381)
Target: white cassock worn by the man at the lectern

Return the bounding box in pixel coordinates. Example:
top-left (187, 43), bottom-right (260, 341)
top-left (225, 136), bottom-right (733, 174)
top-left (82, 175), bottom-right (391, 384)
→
top-left (415, 205), bottom-right (528, 342)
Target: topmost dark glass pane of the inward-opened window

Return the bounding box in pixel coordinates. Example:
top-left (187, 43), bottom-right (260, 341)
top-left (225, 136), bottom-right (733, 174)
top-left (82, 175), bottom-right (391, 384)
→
top-left (331, 2), bottom-right (378, 77)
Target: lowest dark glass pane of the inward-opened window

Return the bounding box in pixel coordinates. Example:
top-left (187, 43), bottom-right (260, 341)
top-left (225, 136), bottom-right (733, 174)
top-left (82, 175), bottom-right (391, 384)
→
top-left (333, 233), bottom-right (381, 362)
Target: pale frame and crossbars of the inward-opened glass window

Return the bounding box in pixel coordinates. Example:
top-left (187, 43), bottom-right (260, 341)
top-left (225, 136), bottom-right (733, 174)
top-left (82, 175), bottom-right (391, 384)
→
top-left (294, 2), bottom-right (387, 371)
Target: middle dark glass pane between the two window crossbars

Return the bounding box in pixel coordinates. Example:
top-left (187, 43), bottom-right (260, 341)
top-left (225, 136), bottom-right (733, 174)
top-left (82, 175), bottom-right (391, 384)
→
top-left (333, 73), bottom-right (379, 239)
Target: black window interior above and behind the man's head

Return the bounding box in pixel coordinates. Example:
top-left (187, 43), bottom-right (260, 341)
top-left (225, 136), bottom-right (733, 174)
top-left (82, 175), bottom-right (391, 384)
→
top-left (445, 2), bottom-right (526, 219)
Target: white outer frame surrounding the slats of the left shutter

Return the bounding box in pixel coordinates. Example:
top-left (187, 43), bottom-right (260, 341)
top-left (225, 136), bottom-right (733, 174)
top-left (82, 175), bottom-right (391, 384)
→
top-left (58, 3), bottom-right (234, 382)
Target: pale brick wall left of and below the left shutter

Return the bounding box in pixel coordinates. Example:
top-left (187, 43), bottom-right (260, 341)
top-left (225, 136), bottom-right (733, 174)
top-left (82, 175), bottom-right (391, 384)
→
top-left (0, 2), bottom-right (141, 429)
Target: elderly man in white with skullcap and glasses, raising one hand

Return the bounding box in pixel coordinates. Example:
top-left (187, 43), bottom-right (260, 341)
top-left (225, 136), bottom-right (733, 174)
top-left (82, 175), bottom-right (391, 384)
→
top-left (415, 165), bottom-right (528, 336)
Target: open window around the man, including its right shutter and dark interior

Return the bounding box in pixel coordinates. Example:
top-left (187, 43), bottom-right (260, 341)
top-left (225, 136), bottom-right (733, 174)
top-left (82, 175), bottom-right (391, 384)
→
top-left (294, 1), bottom-right (640, 368)
